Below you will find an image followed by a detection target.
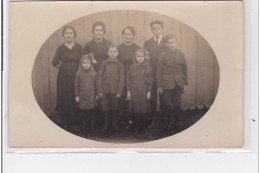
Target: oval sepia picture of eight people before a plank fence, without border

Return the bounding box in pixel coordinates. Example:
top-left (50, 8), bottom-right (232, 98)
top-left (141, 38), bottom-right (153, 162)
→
top-left (32, 10), bottom-right (220, 143)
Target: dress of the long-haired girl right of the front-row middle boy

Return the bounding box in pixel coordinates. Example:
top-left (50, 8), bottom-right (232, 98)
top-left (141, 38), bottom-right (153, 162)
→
top-left (126, 64), bottom-right (153, 114)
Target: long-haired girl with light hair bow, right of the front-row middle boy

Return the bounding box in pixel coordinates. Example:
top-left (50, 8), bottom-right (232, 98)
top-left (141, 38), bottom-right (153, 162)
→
top-left (126, 49), bottom-right (153, 131)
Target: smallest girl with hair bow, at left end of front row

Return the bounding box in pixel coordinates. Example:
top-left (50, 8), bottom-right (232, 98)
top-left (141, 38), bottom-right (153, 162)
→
top-left (75, 55), bottom-right (97, 131)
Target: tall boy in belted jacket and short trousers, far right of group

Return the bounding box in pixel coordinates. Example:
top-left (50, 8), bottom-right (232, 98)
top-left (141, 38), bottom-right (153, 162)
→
top-left (156, 34), bottom-right (188, 132)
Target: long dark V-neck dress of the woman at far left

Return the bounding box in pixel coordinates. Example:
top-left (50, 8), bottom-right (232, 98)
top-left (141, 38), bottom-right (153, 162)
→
top-left (52, 43), bottom-right (82, 113)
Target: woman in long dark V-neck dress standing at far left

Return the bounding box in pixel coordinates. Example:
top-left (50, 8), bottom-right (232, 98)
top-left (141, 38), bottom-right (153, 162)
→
top-left (52, 26), bottom-right (82, 125)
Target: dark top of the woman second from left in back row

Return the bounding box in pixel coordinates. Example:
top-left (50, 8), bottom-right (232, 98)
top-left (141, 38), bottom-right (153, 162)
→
top-left (83, 38), bottom-right (112, 72)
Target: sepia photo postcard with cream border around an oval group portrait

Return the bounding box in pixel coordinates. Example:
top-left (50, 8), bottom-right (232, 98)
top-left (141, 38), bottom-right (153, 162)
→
top-left (7, 1), bottom-right (244, 148)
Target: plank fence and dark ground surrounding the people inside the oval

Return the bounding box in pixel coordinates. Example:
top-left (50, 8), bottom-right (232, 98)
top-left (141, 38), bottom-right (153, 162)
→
top-left (32, 10), bottom-right (220, 143)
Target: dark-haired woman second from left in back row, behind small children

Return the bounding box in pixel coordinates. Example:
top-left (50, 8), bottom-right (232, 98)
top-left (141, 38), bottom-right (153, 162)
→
top-left (83, 22), bottom-right (111, 72)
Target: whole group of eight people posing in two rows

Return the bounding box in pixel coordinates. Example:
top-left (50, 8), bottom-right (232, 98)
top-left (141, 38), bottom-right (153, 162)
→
top-left (52, 20), bottom-right (188, 132)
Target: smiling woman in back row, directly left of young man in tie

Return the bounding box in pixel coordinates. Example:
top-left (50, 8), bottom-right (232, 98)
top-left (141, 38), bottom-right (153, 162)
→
top-left (118, 26), bottom-right (140, 121)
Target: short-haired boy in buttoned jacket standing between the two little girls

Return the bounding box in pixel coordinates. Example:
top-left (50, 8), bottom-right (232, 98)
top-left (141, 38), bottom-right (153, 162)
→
top-left (97, 45), bottom-right (125, 131)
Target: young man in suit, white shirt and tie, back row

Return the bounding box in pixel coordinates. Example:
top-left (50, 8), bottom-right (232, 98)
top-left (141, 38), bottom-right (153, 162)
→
top-left (144, 20), bottom-right (165, 128)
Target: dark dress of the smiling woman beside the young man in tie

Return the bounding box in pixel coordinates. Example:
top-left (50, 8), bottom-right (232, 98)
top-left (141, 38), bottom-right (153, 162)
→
top-left (118, 43), bottom-right (140, 116)
